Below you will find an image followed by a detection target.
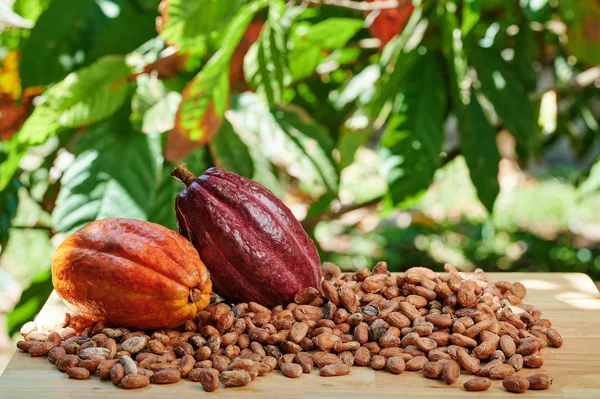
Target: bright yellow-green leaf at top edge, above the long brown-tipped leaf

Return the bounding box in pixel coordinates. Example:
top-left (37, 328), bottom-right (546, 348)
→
top-left (160, 0), bottom-right (244, 52)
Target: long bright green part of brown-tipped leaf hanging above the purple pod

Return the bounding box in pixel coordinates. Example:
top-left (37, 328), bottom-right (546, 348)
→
top-left (175, 0), bottom-right (268, 141)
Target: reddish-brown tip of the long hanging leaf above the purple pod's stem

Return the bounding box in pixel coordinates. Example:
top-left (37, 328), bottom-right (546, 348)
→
top-left (165, 99), bottom-right (223, 163)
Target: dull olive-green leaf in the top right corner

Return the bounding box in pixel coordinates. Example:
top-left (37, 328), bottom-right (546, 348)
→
top-left (558, 0), bottom-right (600, 65)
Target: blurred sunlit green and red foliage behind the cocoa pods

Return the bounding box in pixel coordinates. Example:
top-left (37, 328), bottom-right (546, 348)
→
top-left (0, 0), bottom-right (600, 368)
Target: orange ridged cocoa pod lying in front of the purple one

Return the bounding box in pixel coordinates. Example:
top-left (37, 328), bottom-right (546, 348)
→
top-left (52, 218), bottom-right (212, 329)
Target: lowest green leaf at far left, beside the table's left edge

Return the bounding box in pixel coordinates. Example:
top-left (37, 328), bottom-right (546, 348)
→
top-left (6, 268), bottom-right (52, 336)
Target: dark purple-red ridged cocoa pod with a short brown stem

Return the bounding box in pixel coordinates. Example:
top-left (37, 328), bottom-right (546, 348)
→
top-left (172, 165), bottom-right (321, 307)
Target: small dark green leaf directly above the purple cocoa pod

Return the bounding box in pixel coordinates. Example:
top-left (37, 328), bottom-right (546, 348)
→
top-left (209, 120), bottom-right (254, 179)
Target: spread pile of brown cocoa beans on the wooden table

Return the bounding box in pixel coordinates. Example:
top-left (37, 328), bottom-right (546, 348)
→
top-left (17, 262), bottom-right (563, 392)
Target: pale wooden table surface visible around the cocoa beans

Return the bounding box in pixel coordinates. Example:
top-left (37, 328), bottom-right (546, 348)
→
top-left (0, 273), bottom-right (600, 399)
